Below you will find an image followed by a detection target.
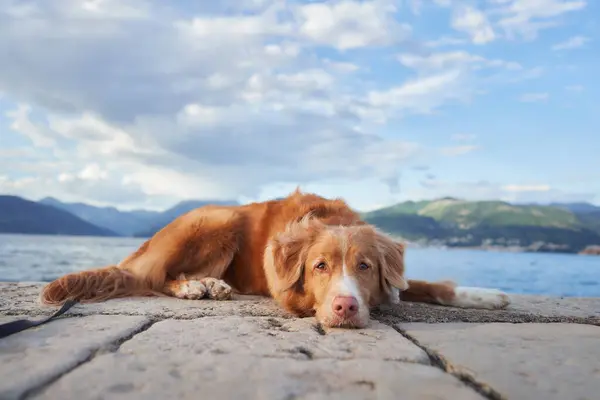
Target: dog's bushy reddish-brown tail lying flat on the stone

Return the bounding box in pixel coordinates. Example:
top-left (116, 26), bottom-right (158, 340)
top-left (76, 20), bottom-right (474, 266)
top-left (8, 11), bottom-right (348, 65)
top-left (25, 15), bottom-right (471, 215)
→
top-left (40, 265), bottom-right (164, 305)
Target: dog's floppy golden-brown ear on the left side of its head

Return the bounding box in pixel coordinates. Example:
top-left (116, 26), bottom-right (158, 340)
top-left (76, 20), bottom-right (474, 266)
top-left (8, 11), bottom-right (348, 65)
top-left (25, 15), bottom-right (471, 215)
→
top-left (266, 216), bottom-right (325, 292)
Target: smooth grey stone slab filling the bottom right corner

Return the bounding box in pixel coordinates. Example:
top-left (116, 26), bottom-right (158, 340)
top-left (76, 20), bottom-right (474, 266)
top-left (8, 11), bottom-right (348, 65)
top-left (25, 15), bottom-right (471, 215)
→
top-left (398, 323), bottom-right (600, 400)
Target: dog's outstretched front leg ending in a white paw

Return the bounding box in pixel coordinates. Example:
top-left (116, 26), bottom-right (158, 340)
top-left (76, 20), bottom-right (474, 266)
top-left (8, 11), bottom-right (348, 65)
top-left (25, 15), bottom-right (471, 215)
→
top-left (400, 280), bottom-right (510, 310)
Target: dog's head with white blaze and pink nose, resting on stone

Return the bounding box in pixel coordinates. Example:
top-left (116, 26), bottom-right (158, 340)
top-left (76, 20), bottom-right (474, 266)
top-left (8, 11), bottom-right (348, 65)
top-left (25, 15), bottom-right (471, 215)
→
top-left (265, 218), bottom-right (408, 328)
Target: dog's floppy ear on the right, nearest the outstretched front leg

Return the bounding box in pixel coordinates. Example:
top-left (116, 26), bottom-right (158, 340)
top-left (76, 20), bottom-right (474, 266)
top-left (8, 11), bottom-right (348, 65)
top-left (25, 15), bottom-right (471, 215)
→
top-left (376, 228), bottom-right (408, 293)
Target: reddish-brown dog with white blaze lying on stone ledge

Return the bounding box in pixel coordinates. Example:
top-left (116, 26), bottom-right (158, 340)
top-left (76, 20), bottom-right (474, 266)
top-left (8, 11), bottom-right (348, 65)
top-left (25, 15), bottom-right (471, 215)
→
top-left (41, 189), bottom-right (509, 328)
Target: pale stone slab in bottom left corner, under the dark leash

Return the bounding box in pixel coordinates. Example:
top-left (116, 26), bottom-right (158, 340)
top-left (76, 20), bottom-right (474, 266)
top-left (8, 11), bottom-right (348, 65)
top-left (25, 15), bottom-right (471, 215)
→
top-left (0, 315), bottom-right (150, 400)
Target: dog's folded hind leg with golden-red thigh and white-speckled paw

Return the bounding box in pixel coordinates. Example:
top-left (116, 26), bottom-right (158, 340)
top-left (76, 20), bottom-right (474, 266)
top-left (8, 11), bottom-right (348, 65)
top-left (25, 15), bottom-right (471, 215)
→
top-left (120, 206), bottom-right (242, 300)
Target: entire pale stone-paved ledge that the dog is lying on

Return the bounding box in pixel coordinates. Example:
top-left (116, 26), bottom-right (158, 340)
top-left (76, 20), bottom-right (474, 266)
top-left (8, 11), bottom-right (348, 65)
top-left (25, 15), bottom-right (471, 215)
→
top-left (0, 282), bottom-right (600, 400)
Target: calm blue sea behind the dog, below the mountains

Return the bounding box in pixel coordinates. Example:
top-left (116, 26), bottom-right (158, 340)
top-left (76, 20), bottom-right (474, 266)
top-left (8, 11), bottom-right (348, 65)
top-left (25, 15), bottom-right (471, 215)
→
top-left (0, 231), bottom-right (600, 297)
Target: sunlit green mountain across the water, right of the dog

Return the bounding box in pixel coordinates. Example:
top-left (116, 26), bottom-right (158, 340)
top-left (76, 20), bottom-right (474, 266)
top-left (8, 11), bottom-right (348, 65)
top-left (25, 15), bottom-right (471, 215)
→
top-left (363, 198), bottom-right (600, 252)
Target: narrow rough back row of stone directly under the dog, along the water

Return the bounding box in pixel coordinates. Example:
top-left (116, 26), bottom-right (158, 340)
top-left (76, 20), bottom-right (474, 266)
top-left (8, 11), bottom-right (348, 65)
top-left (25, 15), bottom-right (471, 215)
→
top-left (0, 282), bottom-right (600, 325)
